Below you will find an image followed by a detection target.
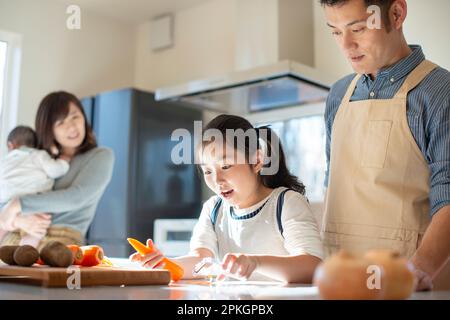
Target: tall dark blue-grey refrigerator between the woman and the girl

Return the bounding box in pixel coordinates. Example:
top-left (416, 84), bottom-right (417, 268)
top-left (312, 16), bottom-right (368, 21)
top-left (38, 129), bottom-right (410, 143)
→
top-left (82, 88), bottom-right (202, 257)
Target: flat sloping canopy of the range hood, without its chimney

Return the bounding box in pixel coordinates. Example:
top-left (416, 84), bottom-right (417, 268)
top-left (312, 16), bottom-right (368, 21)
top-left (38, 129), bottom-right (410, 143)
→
top-left (156, 61), bottom-right (330, 114)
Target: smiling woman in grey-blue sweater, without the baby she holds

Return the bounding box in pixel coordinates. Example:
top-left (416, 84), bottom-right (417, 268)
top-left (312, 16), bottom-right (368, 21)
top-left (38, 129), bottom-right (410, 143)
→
top-left (0, 91), bottom-right (114, 248)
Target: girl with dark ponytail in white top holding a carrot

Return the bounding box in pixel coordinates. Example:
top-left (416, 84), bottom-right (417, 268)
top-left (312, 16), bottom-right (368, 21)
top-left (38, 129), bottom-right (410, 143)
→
top-left (130, 115), bottom-right (323, 283)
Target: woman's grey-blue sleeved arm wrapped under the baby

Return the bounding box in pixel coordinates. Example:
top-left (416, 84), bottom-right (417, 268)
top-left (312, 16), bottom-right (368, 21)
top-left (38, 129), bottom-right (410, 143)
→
top-left (19, 148), bottom-right (114, 214)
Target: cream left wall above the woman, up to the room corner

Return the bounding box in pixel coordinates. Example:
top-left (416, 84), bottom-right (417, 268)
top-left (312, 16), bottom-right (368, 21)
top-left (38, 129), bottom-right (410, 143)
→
top-left (0, 0), bottom-right (135, 126)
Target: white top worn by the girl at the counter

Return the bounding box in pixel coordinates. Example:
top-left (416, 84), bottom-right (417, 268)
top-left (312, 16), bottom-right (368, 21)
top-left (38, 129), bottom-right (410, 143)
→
top-left (190, 187), bottom-right (324, 279)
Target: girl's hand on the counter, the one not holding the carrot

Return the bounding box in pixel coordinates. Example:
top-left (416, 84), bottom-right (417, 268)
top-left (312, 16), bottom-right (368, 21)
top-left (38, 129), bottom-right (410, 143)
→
top-left (217, 253), bottom-right (258, 280)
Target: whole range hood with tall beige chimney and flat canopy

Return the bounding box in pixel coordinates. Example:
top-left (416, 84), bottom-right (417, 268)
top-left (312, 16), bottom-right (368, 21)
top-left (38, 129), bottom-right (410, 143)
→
top-left (155, 0), bottom-right (332, 115)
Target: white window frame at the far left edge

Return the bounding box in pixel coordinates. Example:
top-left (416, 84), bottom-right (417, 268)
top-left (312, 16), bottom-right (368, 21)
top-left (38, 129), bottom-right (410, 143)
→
top-left (0, 30), bottom-right (22, 156)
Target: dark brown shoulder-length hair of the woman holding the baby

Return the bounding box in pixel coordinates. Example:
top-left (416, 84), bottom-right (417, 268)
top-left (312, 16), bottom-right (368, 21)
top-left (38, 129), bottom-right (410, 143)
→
top-left (36, 91), bottom-right (97, 157)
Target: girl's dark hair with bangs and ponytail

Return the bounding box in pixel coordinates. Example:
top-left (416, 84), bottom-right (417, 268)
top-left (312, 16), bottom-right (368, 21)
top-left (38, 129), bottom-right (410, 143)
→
top-left (202, 114), bottom-right (305, 195)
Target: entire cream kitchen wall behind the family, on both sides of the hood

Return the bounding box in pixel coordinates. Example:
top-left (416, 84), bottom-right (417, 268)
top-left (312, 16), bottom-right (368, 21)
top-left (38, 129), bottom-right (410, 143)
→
top-left (0, 0), bottom-right (450, 132)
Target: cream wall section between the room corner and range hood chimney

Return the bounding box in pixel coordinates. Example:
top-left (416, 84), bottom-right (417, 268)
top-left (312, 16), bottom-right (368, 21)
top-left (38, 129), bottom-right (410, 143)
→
top-left (135, 0), bottom-right (235, 90)
